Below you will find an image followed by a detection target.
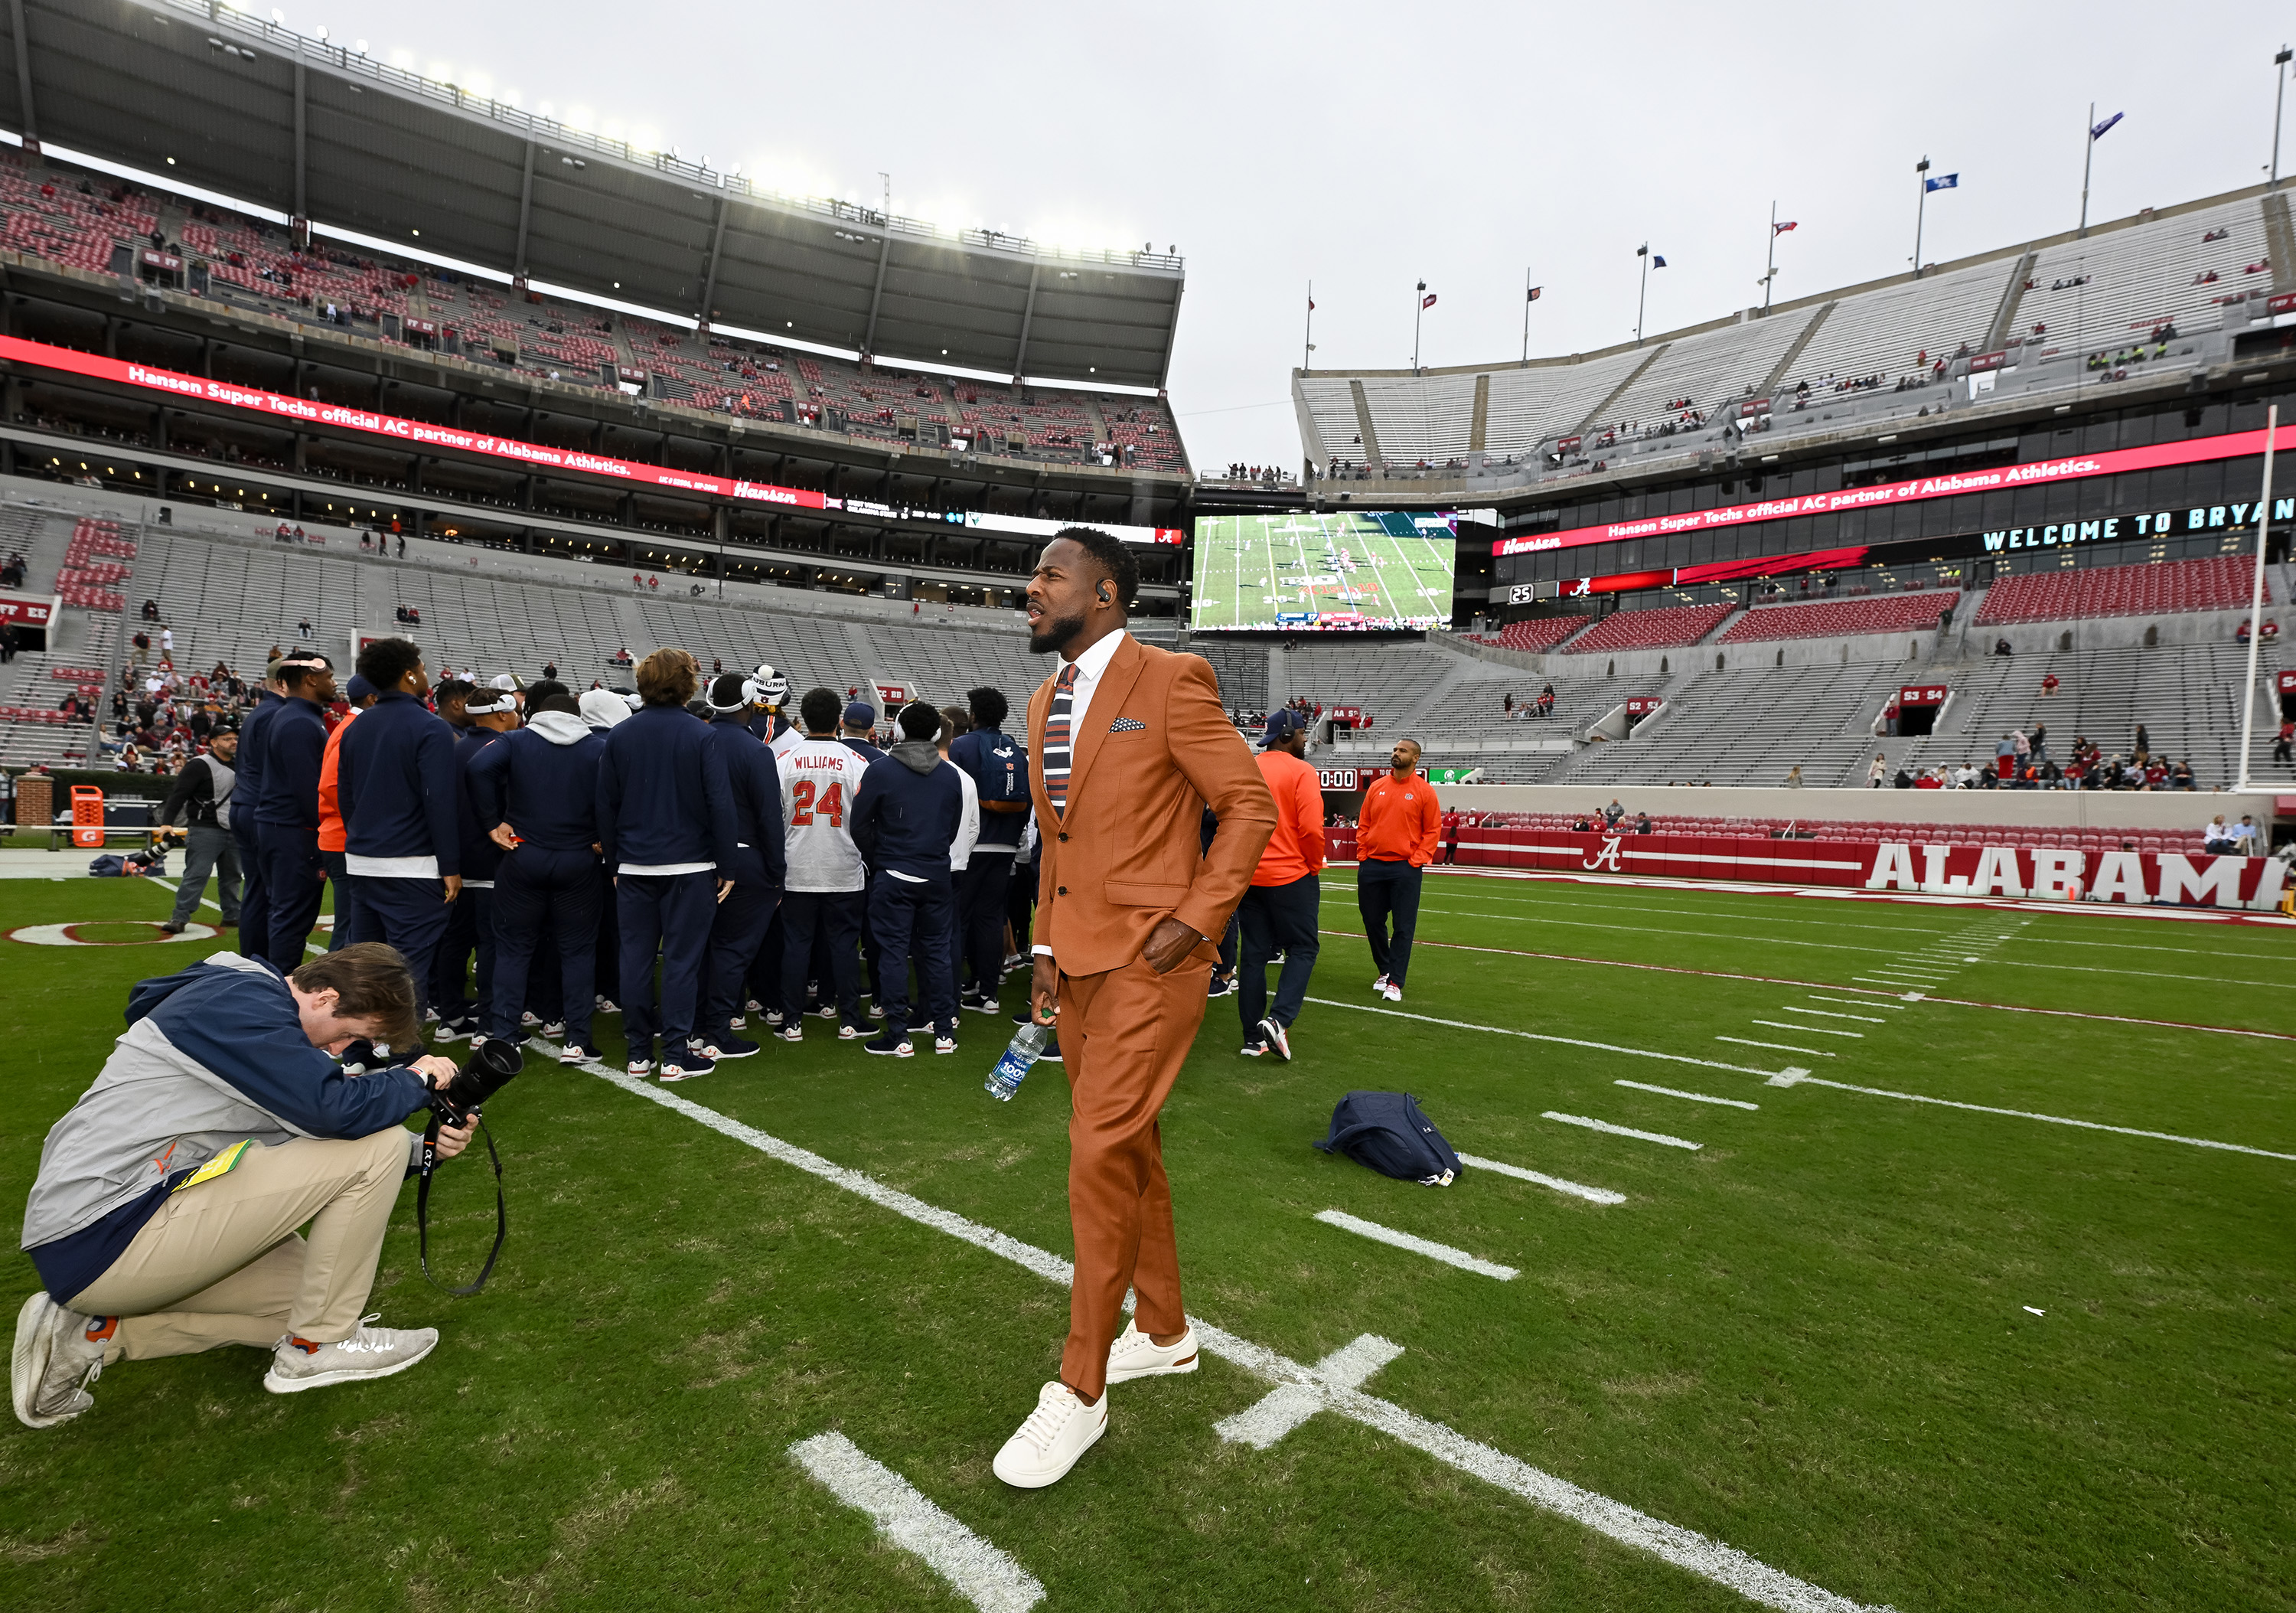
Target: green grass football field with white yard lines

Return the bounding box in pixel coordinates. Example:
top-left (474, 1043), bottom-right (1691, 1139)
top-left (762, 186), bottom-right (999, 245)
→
top-left (0, 860), bottom-right (2296, 1613)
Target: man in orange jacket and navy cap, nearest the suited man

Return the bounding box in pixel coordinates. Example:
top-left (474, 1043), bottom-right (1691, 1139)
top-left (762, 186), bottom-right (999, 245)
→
top-left (1235, 710), bottom-right (1325, 1064)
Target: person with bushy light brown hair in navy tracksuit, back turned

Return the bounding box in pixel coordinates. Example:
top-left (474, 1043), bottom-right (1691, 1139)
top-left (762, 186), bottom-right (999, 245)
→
top-left (597, 648), bottom-right (739, 1082)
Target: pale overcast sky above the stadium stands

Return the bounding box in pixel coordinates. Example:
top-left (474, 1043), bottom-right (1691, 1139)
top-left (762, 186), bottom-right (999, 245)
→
top-left (319, 0), bottom-right (2296, 466)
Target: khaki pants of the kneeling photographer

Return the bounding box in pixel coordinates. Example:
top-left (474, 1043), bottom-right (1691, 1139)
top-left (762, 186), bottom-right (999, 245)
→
top-left (71, 1126), bottom-right (413, 1363)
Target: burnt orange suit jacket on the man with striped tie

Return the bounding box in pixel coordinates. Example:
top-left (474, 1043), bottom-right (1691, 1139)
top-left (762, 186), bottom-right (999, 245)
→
top-left (1029, 634), bottom-right (1277, 975)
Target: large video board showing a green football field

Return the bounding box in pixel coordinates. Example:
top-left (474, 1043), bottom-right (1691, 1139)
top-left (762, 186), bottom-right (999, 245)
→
top-left (1189, 510), bottom-right (1456, 632)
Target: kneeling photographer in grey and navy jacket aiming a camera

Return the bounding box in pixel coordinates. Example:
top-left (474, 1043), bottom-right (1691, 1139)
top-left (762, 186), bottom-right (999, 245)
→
top-left (11, 942), bottom-right (494, 1427)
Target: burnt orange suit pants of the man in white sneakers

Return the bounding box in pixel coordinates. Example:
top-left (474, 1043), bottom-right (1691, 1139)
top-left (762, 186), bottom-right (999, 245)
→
top-left (1061, 945), bottom-right (1217, 1397)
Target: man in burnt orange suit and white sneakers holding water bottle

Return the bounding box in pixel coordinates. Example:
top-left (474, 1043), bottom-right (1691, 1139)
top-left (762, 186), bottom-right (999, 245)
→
top-left (994, 526), bottom-right (1277, 1489)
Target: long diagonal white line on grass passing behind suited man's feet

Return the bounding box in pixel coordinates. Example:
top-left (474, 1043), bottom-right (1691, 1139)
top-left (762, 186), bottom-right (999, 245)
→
top-left (565, 1056), bottom-right (1892, 1613)
